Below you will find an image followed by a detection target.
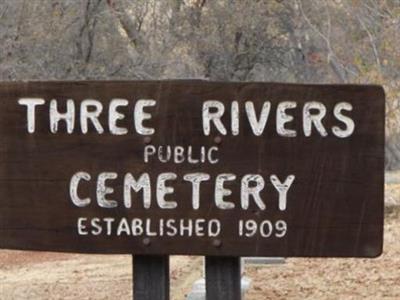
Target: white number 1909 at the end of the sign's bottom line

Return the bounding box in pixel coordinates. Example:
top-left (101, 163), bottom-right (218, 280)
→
top-left (239, 220), bottom-right (287, 238)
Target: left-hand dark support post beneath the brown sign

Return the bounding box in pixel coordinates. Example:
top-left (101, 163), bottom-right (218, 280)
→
top-left (133, 255), bottom-right (169, 300)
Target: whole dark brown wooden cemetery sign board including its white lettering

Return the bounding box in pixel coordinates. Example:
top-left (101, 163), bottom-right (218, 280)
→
top-left (0, 80), bottom-right (385, 257)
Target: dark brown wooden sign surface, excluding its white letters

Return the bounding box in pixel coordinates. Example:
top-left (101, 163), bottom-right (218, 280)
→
top-left (0, 80), bottom-right (385, 257)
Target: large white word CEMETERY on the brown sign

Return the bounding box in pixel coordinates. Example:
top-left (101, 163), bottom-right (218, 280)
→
top-left (70, 172), bottom-right (295, 211)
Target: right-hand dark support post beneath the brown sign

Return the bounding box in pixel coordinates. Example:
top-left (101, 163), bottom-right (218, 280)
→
top-left (206, 256), bottom-right (241, 300)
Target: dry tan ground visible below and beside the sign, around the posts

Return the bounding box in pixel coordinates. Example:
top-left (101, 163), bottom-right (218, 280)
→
top-left (0, 184), bottom-right (400, 300)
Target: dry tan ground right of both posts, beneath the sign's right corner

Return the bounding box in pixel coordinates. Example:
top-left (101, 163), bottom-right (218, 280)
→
top-left (246, 207), bottom-right (400, 300)
